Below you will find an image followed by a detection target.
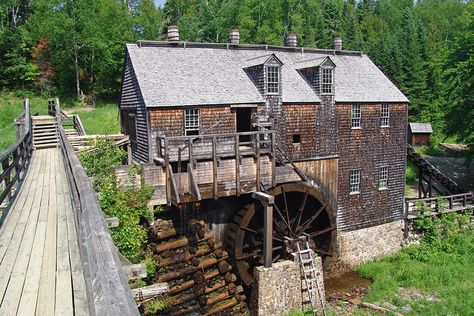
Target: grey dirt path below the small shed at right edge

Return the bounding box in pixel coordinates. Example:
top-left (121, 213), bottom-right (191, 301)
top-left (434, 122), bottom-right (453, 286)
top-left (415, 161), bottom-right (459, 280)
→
top-left (423, 155), bottom-right (474, 191)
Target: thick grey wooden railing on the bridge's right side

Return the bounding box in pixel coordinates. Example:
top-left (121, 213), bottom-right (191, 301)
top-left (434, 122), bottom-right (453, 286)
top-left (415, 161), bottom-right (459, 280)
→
top-left (55, 102), bottom-right (139, 315)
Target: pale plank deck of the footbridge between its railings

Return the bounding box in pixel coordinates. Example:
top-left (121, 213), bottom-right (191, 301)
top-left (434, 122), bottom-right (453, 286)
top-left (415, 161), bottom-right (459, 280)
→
top-left (0, 148), bottom-right (89, 316)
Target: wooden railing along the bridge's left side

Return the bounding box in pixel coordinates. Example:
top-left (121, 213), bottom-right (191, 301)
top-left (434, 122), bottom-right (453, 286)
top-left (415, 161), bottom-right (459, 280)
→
top-left (0, 99), bottom-right (33, 226)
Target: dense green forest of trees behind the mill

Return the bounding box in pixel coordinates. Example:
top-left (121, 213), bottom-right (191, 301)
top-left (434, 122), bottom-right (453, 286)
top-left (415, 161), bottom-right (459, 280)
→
top-left (0, 0), bottom-right (474, 146)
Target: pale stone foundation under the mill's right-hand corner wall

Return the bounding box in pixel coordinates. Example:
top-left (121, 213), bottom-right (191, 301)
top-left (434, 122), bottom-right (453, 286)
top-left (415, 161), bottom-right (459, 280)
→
top-left (329, 220), bottom-right (403, 271)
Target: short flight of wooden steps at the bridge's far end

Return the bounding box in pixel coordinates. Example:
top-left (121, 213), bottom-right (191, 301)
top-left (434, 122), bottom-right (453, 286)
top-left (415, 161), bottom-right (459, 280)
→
top-left (32, 115), bottom-right (59, 149)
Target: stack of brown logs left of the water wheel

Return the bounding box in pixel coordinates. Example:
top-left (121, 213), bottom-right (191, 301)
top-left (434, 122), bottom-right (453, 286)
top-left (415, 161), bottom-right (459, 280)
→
top-left (148, 219), bottom-right (247, 316)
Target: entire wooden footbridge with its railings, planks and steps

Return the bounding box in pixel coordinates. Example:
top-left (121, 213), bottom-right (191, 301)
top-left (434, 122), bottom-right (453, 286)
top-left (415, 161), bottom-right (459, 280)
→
top-left (0, 100), bottom-right (139, 315)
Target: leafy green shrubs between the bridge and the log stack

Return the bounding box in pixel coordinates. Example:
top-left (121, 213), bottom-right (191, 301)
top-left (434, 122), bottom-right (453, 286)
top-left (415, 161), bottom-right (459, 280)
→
top-left (80, 141), bottom-right (153, 263)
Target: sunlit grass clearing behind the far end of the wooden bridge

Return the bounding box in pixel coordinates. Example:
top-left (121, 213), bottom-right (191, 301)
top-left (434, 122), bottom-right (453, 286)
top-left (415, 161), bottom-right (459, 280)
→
top-left (0, 94), bottom-right (120, 152)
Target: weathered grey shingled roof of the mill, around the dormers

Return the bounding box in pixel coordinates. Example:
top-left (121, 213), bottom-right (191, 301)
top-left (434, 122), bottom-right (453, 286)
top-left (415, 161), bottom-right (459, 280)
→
top-left (127, 42), bottom-right (408, 107)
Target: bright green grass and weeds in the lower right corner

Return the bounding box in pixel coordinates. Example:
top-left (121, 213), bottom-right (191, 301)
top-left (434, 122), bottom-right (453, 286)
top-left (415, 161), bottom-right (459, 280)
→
top-left (358, 213), bottom-right (474, 315)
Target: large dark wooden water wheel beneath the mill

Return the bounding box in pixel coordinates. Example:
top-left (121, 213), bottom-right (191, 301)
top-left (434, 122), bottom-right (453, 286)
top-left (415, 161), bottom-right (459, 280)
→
top-left (226, 183), bottom-right (336, 286)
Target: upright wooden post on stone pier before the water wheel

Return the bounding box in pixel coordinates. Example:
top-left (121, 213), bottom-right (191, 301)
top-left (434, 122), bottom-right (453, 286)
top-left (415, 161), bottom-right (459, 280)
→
top-left (252, 192), bottom-right (275, 268)
